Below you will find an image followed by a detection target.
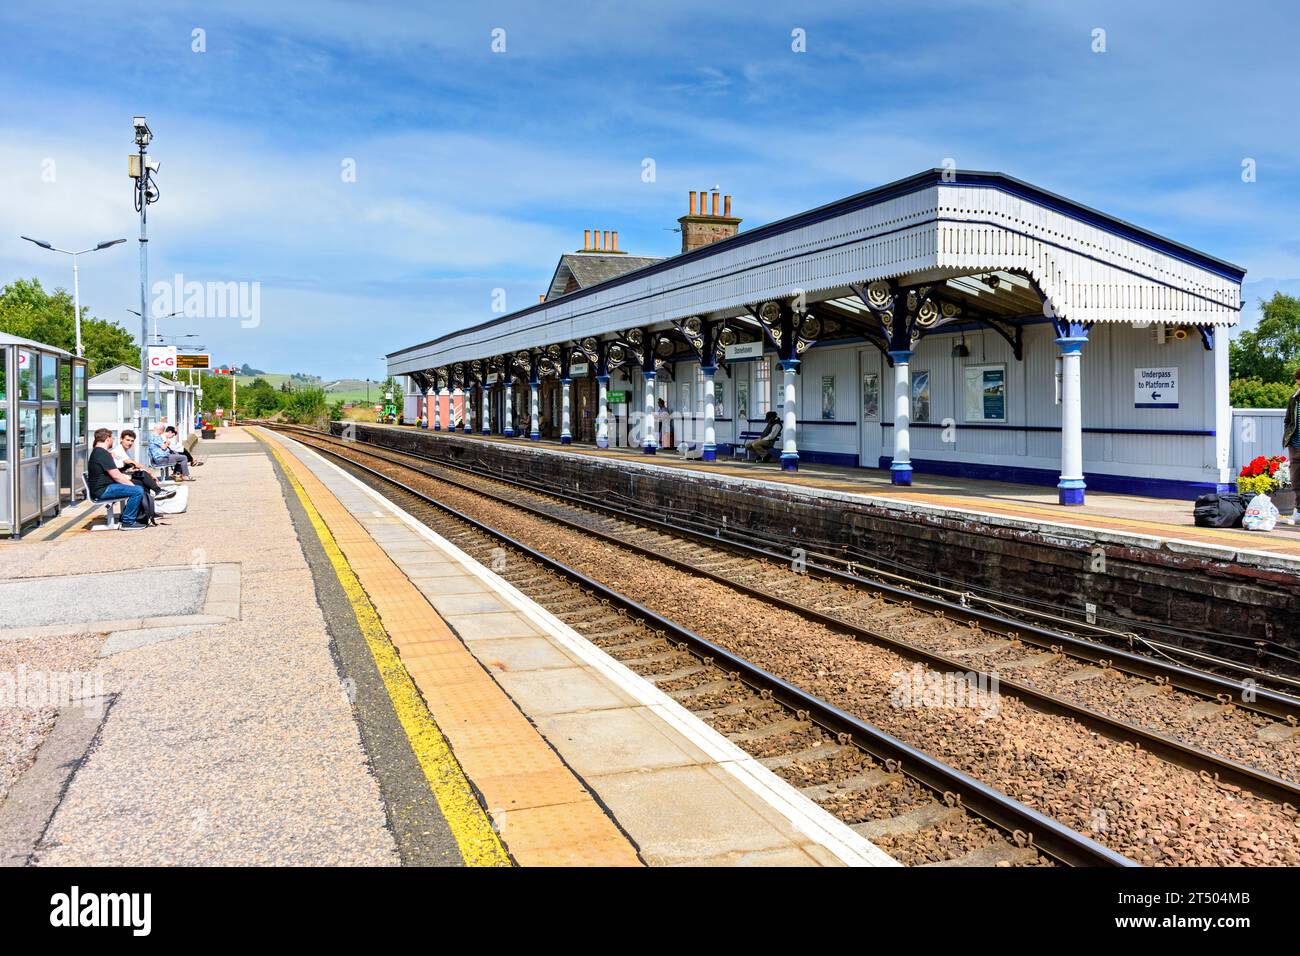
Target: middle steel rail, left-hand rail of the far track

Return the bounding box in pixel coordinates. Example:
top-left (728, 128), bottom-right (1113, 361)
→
top-left (276, 434), bottom-right (1300, 805)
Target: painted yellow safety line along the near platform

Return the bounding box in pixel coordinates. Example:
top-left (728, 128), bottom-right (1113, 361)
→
top-left (254, 432), bottom-right (511, 866)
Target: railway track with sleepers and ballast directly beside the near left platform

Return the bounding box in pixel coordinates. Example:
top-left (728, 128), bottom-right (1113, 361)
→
top-left (266, 429), bottom-right (1132, 866)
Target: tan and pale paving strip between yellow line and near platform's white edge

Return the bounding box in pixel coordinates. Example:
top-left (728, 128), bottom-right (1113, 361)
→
top-left (264, 433), bottom-right (892, 865)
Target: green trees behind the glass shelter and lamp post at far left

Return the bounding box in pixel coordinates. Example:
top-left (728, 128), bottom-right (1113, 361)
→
top-left (0, 278), bottom-right (140, 375)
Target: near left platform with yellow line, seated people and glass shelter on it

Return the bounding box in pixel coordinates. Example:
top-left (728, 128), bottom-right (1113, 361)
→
top-left (0, 428), bottom-right (894, 866)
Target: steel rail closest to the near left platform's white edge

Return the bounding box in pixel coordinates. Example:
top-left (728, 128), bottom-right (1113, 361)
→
top-left (274, 429), bottom-right (1138, 866)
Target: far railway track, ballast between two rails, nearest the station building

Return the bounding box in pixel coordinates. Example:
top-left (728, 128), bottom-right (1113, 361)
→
top-left (287, 429), bottom-right (1300, 785)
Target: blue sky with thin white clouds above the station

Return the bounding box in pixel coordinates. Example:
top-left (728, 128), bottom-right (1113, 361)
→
top-left (0, 0), bottom-right (1300, 377)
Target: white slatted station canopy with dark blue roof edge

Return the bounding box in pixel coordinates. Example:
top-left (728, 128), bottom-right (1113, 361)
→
top-left (387, 169), bottom-right (1245, 380)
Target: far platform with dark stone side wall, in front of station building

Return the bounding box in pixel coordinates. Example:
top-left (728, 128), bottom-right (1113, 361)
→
top-left (345, 423), bottom-right (1300, 666)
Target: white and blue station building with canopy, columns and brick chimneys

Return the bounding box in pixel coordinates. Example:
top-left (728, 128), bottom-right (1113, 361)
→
top-left (387, 169), bottom-right (1245, 505)
